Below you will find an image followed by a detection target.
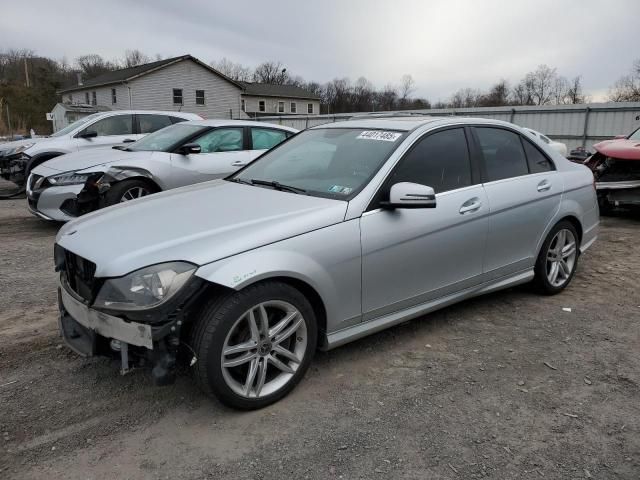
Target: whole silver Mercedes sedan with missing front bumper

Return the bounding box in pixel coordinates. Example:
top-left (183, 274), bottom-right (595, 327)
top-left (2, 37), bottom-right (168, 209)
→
top-left (55, 117), bottom-right (599, 409)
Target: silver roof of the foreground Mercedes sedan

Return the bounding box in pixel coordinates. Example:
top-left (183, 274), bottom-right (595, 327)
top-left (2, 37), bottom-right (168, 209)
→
top-left (313, 115), bottom-right (520, 132)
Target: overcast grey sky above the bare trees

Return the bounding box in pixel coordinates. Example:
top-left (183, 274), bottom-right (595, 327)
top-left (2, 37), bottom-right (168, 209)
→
top-left (0, 0), bottom-right (640, 102)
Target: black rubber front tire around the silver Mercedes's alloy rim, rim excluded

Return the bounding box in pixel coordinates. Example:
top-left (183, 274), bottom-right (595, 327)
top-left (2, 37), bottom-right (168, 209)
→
top-left (198, 282), bottom-right (317, 410)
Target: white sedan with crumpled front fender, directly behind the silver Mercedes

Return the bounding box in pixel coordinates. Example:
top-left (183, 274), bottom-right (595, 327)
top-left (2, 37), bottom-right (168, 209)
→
top-left (27, 120), bottom-right (297, 222)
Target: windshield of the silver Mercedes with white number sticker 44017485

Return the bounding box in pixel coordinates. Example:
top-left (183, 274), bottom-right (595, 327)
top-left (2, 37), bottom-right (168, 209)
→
top-left (230, 128), bottom-right (404, 200)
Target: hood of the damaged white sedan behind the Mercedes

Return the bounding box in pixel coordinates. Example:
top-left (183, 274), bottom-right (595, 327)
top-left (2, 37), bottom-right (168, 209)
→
top-left (33, 147), bottom-right (153, 175)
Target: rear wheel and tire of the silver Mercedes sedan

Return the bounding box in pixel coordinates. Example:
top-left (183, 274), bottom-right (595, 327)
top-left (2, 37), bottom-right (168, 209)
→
top-left (534, 220), bottom-right (580, 295)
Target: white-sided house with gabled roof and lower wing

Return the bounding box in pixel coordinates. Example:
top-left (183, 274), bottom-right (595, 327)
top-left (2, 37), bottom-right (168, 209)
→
top-left (52, 55), bottom-right (320, 124)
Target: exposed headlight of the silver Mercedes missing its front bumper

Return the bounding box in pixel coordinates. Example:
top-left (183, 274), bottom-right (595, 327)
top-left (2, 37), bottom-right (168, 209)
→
top-left (94, 262), bottom-right (196, 311)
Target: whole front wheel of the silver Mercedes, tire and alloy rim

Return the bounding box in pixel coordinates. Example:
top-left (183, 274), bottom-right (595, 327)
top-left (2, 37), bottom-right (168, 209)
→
top-left (192, 281), bottom-right (318, 410)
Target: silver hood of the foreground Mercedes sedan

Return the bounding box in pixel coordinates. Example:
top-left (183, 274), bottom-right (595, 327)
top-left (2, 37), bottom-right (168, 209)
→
top-left (56, 180), bottom-right (347, 277)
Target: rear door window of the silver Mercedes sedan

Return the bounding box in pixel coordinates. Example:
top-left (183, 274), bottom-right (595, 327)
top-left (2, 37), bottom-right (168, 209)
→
top-left (475, 127), bottom-right (529, 182)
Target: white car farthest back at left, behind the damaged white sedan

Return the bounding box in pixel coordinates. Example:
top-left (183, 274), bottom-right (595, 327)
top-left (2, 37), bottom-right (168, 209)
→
top-left (0, 110), bottom-right (202, 187)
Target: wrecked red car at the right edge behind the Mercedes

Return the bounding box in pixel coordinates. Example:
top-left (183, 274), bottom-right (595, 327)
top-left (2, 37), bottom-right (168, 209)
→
top-left (585, 128), bottom-right (640, 213)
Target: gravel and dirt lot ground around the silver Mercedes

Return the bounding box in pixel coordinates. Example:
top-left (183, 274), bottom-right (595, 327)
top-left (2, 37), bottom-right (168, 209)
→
top-left (0, 189), bottom-right (640, 480)
